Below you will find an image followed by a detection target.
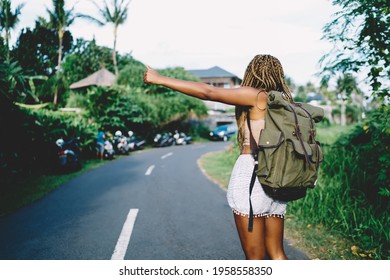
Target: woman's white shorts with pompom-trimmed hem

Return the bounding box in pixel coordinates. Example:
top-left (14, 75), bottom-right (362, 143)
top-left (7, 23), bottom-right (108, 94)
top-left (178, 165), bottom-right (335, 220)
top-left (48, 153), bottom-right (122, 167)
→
top-left (227, 154), bottom-right (287, 218)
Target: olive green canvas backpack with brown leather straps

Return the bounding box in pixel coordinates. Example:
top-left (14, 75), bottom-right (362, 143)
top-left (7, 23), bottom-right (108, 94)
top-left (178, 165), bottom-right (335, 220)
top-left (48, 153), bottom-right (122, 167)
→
top-left (247, 91), bottom-right (324, 231)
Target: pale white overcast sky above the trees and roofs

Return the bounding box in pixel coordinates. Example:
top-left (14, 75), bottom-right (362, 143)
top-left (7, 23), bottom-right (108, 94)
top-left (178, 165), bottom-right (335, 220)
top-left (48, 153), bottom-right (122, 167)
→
top-left (12, 0), bottom-right (337, 84)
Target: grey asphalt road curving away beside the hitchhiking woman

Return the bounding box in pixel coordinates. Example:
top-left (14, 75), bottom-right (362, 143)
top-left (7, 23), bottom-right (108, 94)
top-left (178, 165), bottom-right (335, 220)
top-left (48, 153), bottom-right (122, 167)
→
top-left (0, 142), bottom-right (307, 260)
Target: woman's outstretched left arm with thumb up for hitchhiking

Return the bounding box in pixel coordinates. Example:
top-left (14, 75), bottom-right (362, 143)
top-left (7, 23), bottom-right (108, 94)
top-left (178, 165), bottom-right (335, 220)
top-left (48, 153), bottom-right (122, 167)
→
top-left (144, 66), bottom-right (259, 106)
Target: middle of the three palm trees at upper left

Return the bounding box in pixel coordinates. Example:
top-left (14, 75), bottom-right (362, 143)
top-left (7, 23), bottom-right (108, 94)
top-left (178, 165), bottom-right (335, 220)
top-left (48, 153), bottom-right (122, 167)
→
top-left (46, 0), bottom-right (78, 106)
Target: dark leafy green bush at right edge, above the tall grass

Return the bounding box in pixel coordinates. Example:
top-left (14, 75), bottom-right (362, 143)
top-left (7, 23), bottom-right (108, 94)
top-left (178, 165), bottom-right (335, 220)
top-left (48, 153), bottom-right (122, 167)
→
top-left (325, 106), bottom-right (390, 201)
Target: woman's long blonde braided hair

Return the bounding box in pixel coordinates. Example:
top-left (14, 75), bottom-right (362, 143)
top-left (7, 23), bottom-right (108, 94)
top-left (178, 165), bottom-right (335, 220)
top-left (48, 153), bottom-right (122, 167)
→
top-left (236, 54), bottom-right (293, 149)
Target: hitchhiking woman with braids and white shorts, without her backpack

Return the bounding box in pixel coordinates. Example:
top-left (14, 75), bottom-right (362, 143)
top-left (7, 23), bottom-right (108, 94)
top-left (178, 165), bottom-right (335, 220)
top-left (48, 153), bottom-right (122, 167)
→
top-left (144, 55), bottom-right (292, 260)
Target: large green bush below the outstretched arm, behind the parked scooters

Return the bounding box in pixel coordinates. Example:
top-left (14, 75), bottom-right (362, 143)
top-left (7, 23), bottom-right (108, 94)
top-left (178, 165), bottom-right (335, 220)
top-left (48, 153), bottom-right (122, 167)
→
top-left (87, 82), bottom-right (207, 138)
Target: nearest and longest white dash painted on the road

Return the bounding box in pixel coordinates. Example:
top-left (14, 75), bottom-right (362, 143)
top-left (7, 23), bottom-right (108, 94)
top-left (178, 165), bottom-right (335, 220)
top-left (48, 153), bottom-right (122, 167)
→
top-left (111, 209), bottom-right (138, 260)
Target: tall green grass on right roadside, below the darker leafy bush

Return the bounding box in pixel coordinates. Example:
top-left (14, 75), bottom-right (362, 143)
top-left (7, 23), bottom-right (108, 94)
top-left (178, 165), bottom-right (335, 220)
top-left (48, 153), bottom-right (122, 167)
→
top-left (289, 144), bottom-right (390, 259)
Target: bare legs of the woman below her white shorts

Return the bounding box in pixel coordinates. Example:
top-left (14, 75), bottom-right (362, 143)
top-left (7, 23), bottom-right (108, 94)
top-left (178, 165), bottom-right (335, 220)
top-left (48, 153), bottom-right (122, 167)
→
top-left (234, 214), bottom-right (287, 260)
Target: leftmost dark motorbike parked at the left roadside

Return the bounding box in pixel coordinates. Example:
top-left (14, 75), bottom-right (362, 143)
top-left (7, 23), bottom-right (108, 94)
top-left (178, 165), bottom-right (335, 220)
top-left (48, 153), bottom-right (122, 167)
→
top-left (56, 137), bottom-right (81, 172)
